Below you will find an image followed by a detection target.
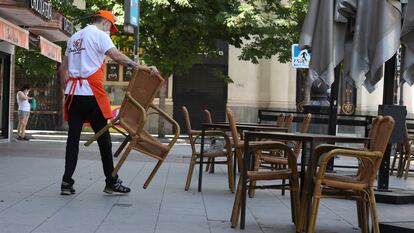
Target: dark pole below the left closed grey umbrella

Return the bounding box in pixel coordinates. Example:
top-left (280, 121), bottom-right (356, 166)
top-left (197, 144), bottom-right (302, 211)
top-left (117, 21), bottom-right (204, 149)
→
top-left (326, 63), bottom-right (341, 171)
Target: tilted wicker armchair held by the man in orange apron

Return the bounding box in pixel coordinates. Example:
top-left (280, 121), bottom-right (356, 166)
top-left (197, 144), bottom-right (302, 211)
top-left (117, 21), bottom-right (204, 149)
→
top-left (85, 66), bottom-right (180, 189)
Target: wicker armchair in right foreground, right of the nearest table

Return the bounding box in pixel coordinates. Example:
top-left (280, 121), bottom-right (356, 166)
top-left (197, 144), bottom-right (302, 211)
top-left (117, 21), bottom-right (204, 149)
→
top-left (307, 116), bottom-right (395, 233)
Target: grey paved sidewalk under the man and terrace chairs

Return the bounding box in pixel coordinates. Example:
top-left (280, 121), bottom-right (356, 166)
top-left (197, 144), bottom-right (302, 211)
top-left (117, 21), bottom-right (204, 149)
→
top-left (0, 142), bottom-right (414, 233)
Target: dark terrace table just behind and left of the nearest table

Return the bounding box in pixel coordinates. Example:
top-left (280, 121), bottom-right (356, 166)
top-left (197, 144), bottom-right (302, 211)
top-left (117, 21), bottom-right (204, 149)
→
top-left (198, 122), bottom-right (288, 192)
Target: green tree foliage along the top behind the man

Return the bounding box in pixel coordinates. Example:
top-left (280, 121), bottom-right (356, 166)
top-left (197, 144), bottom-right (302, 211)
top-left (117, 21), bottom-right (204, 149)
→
top-left (17, 0), bottom-right (307, 82)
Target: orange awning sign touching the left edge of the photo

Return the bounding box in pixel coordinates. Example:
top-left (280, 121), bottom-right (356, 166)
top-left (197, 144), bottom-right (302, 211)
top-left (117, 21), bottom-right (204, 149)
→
top-left (0, 18), bottom-right (29, 49)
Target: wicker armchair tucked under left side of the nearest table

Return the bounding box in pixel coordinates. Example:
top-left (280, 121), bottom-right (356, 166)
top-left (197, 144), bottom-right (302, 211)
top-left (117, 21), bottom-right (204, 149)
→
top-left (231, 142), bottom-right (300, 228)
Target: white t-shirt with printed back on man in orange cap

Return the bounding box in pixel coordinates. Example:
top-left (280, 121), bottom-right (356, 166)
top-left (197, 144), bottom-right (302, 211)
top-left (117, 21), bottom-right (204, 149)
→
top-left (65, 25), bottom-right (115, 96)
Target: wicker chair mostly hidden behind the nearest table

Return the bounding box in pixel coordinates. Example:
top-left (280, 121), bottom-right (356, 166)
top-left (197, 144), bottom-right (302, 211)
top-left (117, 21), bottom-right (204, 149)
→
top-left (249, 113), bottom-right (312, 197)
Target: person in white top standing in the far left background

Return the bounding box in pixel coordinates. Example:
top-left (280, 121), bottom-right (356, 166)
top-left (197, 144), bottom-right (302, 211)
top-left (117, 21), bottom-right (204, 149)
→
top-left (16, 84), bottom-right (32, 141)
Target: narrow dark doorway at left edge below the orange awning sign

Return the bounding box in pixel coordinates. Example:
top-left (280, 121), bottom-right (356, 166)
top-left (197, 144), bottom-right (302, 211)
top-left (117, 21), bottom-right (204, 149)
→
top-left (0, 52), bottom-right (10, 139)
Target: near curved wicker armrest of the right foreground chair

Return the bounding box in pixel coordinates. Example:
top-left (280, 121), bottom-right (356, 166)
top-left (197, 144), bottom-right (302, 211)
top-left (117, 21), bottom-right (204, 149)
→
top-left (318, 149), bottom-right (382, 178)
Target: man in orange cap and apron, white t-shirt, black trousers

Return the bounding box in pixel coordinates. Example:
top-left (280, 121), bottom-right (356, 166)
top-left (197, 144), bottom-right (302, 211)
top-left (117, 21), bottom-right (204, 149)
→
top-left (59, 10), bottom-right (158, 195)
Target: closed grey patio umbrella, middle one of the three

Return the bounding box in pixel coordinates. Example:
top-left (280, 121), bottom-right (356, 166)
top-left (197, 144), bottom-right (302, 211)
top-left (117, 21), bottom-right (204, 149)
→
top-left (338, 0), bottom-right (401, 92)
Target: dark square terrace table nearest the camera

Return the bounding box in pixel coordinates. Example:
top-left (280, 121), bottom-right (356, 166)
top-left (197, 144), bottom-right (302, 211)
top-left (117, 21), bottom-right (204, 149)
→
top-left (240, 131), bottom-right (370, 231)
